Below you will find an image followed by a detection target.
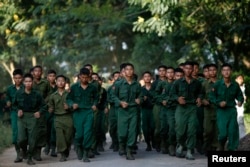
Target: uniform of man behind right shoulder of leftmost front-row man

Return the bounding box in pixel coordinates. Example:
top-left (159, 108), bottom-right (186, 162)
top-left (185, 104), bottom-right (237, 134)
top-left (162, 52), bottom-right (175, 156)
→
top-left (33, 79), bottom-right (50, 150)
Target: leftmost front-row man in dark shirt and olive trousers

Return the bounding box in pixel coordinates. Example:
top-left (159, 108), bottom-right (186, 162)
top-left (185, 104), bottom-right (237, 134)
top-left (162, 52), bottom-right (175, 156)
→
top-left (14, 74), bottom-right (46, 165)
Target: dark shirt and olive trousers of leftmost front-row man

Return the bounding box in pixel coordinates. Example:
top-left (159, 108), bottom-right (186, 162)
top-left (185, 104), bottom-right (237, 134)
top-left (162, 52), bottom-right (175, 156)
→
top-left (13, 89), bottom-right (46, 158)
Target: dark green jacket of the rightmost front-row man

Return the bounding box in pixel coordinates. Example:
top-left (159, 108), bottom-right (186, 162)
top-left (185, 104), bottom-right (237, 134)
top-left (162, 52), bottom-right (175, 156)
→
top-left (209, 79), bottom-right (244, 107)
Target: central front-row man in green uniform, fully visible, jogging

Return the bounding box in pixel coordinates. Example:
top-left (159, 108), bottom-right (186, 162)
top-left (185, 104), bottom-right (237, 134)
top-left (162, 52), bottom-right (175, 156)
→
top-left (112, 63), bottom-right (141, 160)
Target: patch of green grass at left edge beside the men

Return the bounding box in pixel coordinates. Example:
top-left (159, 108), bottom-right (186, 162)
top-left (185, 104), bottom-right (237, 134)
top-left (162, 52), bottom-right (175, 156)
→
top-left (0, 120), bottom-right (12, 154)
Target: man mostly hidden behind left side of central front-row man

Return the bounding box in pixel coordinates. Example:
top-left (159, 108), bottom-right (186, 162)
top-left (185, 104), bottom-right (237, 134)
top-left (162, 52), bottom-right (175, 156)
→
top-left (108, 71), bottom-right (120, 152)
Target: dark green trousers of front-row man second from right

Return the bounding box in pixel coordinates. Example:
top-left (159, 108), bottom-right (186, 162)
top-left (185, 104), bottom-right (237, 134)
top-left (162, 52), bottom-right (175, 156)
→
top-left (175, 104), bottom-right (197, 149)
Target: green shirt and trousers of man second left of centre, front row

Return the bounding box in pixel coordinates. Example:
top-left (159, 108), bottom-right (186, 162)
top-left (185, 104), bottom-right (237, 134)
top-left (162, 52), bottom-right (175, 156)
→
top-left (66, 82), bottom-right (99, 151)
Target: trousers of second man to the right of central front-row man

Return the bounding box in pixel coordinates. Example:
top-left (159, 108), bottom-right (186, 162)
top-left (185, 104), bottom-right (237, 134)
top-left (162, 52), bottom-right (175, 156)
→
top-left (153, 104), bottom-right (161, 149)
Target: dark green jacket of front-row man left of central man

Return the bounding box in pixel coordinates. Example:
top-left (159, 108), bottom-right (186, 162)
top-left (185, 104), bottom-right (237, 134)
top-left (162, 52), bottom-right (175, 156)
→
top-left (66, 82), bottom-right (99, 109)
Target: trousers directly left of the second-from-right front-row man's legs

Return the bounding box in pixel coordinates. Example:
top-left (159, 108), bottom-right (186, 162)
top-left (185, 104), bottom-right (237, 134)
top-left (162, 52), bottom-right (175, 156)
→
top-left (160, 106), bottom-right (169, 149)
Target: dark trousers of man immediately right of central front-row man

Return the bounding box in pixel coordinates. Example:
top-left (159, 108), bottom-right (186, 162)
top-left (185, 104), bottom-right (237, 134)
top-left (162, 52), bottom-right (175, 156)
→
top-left (141, 108), bottom-right (154, 144)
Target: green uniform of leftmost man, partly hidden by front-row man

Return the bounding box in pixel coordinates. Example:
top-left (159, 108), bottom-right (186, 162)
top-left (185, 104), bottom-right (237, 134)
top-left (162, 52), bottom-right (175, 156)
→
top-left (6, 85), bottom-right (23, 144)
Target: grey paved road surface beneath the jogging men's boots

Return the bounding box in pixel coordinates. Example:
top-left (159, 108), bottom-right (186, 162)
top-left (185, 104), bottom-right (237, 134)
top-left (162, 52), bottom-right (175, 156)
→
top-left (0, 135), bottom-right (207, 167)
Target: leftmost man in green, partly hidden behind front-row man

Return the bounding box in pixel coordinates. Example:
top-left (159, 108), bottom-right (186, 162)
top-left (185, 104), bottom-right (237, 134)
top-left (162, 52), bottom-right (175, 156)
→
top-left (6, 69), bottom-right (23, 163)
